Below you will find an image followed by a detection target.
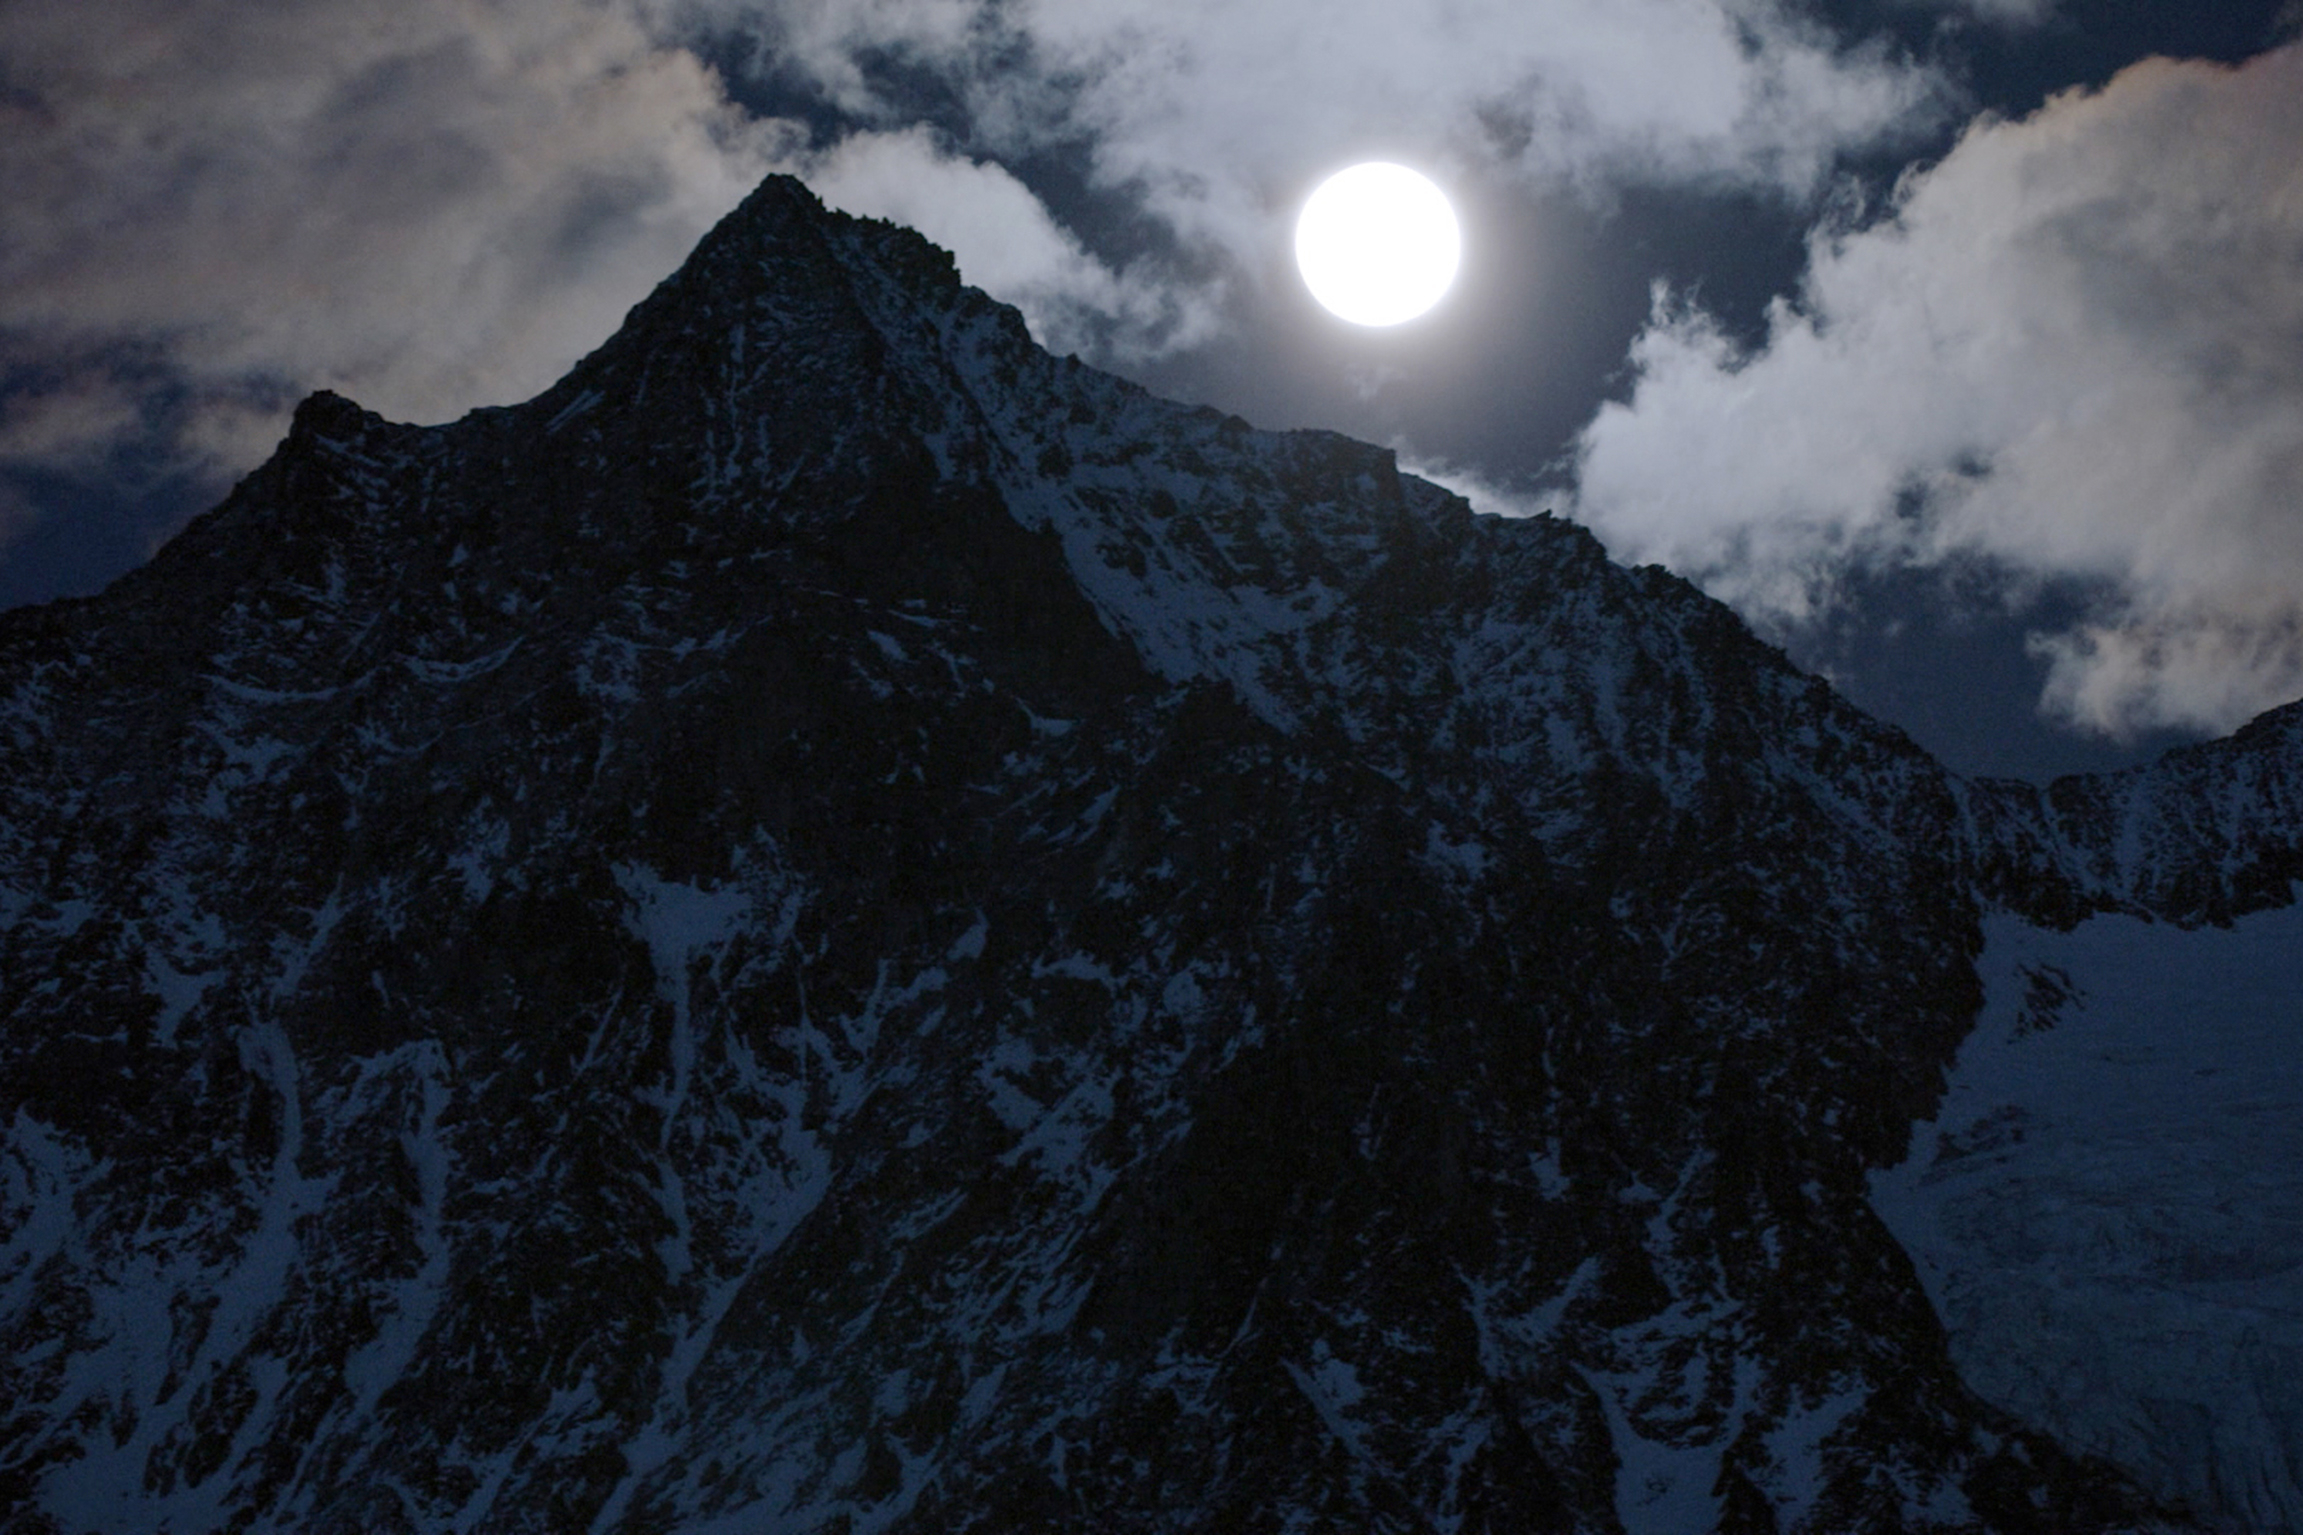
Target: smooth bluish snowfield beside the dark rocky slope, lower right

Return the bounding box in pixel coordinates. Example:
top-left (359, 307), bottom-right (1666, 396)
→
top-left (1872, 907), bottom-right (2303, 1530)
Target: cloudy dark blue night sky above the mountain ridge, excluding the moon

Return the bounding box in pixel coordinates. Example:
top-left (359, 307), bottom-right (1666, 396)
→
top-left (0, 0), bottom-right (2303, 778)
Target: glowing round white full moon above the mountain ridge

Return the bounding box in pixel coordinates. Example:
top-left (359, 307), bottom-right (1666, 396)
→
top-left (1297, 161), bottom-right (1462, 324)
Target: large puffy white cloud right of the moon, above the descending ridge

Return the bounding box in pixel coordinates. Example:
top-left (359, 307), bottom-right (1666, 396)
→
top-left (1580, 48), bottom-right (2303, 732)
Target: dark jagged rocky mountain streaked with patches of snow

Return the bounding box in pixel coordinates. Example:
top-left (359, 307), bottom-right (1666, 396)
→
top-left (0, 180), bottom-right (2303, 1535)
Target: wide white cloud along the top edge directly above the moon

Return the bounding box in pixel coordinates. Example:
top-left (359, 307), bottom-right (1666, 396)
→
top-left (736, 0), bottom-right (1937, 269)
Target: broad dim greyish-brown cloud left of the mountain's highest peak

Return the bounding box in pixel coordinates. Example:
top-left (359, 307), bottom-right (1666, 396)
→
top-left (0, 0), bottom-right (783, 492)
